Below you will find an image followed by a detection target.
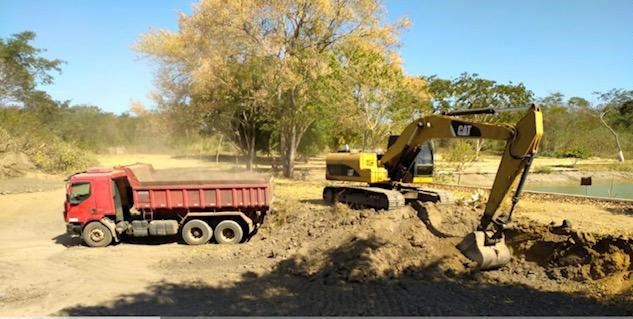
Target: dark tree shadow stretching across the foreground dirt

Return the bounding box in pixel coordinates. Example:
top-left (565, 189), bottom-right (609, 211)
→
top-left (57, 239), bottom-right (631, 316)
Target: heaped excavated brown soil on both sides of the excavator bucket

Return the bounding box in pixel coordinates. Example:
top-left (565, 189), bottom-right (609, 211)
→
top-left (273, 196), bottom-right (633, 294)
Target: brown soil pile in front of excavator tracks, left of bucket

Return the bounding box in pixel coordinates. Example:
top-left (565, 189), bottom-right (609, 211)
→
top-left (278, 205), bottom-right (467, 283)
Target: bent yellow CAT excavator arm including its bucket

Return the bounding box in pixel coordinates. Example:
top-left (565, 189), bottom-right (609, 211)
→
top-left (381, 105), bottom-right (543, 269)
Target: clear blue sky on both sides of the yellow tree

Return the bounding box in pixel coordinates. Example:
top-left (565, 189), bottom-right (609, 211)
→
top-left (0, 0), bottom-right (633, 113)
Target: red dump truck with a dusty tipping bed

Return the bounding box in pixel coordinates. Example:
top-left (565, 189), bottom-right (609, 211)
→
top-left (64, 163), bottom-right (272, 247)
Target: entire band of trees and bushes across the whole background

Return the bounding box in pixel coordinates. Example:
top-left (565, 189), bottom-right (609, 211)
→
top-left (0, 0), bottom-right (633, 177)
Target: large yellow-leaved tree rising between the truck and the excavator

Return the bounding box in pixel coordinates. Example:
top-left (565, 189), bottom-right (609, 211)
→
top-left (137, 0), bottom-right (407, 177)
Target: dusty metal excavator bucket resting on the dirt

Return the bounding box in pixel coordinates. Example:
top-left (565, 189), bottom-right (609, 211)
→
top-left (457, 231), bottom-right (511, 270)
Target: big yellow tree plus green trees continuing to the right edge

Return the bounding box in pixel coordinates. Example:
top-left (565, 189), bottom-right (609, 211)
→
top-left (136, 0), bottom-right (630, 176)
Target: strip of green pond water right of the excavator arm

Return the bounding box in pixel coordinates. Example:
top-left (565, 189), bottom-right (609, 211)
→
top-left (525, 183), bottom-right (633, 199)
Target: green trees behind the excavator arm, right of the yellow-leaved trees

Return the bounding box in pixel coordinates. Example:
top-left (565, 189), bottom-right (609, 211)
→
top-left (426, 73), bottom-right (633, 158)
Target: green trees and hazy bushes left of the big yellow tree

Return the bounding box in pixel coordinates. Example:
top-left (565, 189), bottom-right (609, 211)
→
top-left (0, 32), bottom-right (191, 175)
